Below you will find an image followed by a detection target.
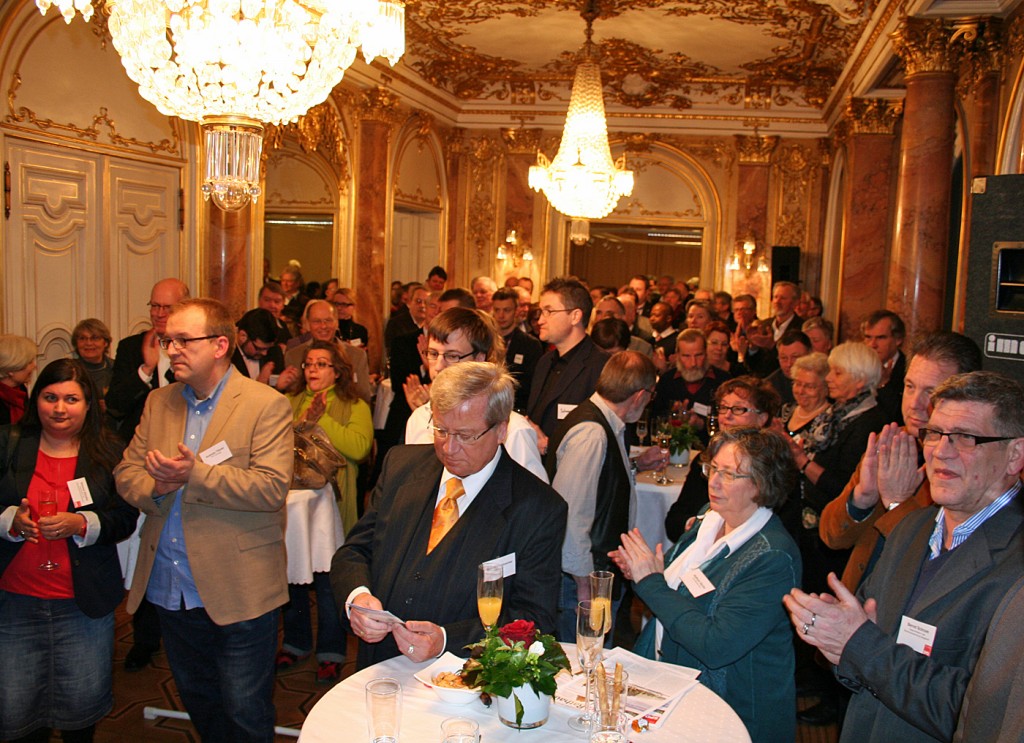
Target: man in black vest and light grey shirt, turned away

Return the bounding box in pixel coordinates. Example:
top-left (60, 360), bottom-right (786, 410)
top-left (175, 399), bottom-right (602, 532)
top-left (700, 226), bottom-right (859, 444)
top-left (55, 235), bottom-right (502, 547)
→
top-left (545, 351), bottom-right (668, 643)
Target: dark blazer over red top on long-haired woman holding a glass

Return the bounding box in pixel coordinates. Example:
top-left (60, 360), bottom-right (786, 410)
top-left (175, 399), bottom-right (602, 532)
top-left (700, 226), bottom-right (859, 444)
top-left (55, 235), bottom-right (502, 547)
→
top-left (0, 426), bottom-right (138, 618)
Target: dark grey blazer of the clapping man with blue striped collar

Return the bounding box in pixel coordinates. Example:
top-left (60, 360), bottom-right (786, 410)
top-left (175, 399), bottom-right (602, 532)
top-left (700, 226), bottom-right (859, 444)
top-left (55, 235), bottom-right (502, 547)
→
top-left (837, 494), bottom-right (1024, 743)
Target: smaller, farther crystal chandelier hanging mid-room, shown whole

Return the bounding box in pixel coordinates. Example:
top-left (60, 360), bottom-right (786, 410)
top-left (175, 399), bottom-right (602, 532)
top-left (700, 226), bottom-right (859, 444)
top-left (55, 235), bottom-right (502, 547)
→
top-left (528, 0), bottom-right (633, 244)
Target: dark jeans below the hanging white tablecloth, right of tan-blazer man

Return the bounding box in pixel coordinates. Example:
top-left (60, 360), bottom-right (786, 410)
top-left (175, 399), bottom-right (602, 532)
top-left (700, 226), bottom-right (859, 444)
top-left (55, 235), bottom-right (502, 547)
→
top-left (282, 573), bottom-right (345, 663)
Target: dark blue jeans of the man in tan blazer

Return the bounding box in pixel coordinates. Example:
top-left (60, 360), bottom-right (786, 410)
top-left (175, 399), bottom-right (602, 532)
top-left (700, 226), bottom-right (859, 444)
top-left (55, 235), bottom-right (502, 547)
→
top-left (157, 606), bottom-right (278, 743)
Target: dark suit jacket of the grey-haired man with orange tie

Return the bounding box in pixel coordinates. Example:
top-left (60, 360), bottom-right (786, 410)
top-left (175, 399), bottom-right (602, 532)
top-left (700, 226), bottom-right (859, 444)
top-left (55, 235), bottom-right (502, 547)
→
top-left (331, 445), bottom-right (567, 667)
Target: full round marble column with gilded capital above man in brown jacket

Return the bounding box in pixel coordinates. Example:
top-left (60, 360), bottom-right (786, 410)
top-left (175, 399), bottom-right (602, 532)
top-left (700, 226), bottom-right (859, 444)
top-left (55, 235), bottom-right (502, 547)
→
top-left (886, 18), bottom-right (955, 336)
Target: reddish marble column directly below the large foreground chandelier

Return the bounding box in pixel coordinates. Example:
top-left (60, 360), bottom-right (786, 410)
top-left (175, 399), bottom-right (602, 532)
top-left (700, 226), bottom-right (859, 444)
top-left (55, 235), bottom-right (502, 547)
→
top-left (202, 202), bottom-right (253, 317)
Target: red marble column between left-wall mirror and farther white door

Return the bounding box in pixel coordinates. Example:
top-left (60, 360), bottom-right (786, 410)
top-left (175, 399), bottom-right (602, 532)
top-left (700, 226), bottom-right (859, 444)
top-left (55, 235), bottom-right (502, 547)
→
top-left (353, 87), bottom-right (399, 372)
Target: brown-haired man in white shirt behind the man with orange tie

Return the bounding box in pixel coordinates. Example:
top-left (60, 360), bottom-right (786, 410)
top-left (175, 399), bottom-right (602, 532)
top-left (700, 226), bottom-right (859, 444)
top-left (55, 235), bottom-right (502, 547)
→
top-left (406, 307), bottom-right (548, 482)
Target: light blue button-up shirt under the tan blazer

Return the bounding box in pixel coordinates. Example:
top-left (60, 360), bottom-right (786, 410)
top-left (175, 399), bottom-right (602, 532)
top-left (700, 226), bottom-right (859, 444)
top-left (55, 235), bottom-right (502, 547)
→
top-left (145, 366), bottom-right (233, 611)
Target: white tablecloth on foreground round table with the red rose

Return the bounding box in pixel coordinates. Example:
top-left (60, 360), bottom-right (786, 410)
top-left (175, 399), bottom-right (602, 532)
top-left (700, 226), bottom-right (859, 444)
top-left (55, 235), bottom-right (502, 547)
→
top-left (299, 651), bottom-right (751, 743)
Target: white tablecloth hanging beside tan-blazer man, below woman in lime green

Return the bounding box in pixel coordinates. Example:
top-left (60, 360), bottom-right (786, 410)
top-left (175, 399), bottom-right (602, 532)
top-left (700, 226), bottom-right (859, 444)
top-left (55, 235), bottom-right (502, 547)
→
top-left (285, 483), bottom-right (345, 583)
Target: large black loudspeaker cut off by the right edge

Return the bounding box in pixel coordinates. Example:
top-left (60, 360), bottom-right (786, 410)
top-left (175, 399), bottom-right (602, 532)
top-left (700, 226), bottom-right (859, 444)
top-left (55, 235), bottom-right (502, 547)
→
top-left (964, 175), bottom-right (1024, 382)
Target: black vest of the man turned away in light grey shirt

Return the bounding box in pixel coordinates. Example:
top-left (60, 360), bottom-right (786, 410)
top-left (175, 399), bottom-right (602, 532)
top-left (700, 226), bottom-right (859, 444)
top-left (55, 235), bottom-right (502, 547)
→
top-left (544, 400), bottom-right (631, 581)
